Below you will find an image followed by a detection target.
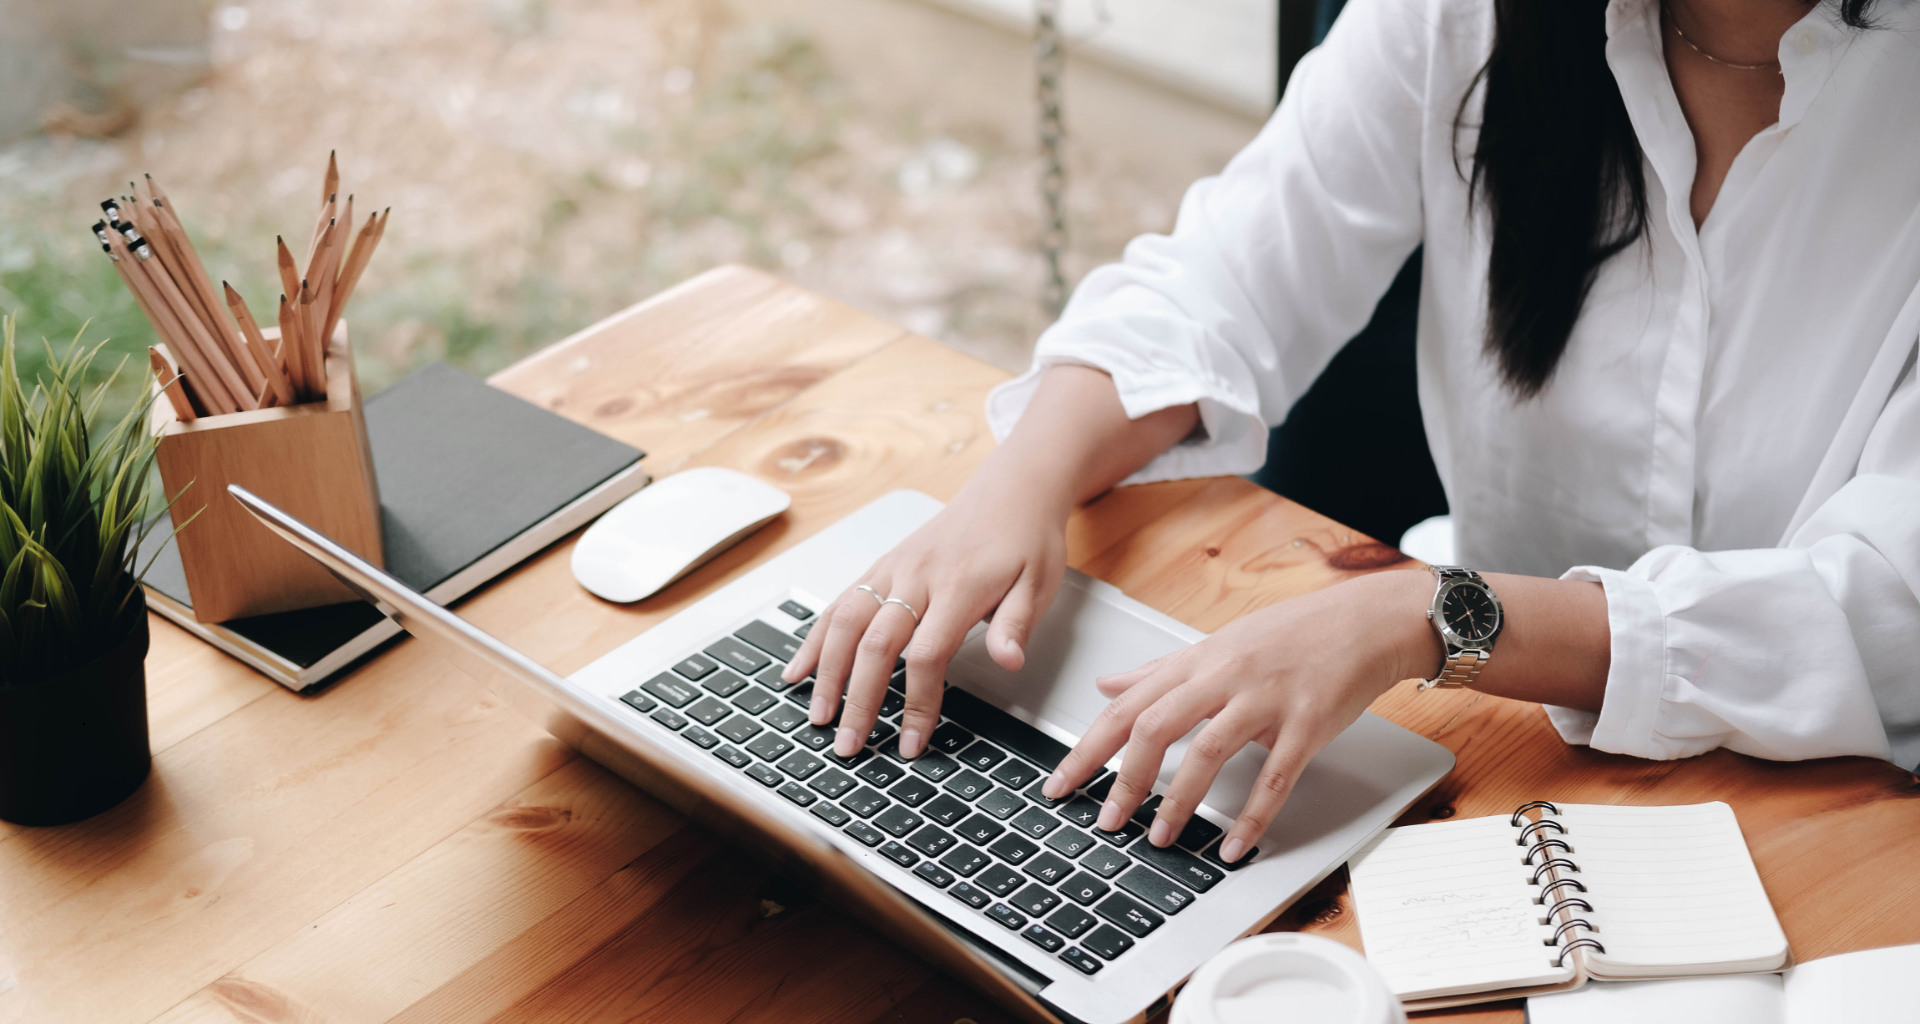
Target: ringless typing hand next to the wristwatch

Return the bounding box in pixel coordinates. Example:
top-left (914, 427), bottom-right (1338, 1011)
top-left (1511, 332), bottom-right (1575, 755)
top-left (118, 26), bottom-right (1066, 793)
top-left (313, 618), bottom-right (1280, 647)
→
top-left (1044, 571), bottom-right (1440, 863)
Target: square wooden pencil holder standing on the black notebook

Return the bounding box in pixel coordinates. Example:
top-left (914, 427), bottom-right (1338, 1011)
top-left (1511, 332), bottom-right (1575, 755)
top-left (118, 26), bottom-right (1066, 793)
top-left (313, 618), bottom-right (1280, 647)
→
top-left (154, 321), bottom-right (384, 622)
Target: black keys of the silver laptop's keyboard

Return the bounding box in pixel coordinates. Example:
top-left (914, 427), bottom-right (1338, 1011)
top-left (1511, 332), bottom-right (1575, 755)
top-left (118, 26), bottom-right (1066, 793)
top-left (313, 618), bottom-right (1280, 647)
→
top-left (620, 601), bottom-right (1258, 974)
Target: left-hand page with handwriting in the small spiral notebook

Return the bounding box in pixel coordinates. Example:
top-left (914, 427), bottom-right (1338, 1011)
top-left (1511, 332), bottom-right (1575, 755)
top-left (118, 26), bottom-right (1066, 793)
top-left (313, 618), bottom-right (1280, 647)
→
top-left (1348, 815), bottom-right (1574, 999)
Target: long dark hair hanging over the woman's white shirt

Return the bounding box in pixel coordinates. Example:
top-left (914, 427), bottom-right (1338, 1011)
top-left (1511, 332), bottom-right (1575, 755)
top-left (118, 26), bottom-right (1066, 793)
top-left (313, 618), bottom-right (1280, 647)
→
top-left (1453, 0), bottom-right (1874, 400)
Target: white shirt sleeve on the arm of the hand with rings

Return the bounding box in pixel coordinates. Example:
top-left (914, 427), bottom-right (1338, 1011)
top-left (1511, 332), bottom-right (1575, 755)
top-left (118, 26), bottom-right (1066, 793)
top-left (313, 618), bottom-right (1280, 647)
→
top-left (987, 0), bottom-right (1432, 482)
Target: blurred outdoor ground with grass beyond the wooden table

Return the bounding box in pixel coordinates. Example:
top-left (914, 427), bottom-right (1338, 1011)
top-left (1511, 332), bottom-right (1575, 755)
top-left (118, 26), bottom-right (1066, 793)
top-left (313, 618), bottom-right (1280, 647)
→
top-left (0, 0), bottom-right (1275, 418)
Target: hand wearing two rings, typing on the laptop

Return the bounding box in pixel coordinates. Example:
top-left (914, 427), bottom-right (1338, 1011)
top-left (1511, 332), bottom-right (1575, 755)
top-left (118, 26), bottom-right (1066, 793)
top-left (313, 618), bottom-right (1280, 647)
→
top-left (781, 459), bottom-right (1073, 757)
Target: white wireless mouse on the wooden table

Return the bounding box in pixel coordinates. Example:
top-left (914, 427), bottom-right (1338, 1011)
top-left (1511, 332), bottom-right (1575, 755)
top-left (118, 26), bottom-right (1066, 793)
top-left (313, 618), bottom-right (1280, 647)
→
top-left (574, 467), bottom-right (793, 603)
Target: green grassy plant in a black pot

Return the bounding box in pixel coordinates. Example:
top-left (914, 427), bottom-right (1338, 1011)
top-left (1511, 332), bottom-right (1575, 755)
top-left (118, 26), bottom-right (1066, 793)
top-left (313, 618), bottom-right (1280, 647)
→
top-left (0, 319), bottom-right (186, 824)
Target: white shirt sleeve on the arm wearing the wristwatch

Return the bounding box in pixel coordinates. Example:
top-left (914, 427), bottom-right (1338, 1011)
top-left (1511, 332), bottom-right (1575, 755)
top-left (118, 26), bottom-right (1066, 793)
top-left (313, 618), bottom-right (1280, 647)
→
top-left (1548, 359), bottom-right (1920, 767)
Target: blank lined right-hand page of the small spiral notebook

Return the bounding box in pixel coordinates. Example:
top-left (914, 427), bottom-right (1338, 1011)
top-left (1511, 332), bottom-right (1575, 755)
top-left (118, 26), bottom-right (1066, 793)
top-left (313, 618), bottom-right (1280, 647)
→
top-left (1559, 801), bottom-right (1788, 978)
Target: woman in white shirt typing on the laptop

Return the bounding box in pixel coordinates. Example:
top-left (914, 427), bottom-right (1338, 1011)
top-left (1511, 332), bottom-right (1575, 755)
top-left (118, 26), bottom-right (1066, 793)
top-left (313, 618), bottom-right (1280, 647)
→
top-left (789, 0), bottom-right (1920, 861)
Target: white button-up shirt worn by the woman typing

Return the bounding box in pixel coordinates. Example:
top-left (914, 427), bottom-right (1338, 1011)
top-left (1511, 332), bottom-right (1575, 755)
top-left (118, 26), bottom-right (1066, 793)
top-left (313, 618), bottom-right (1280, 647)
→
top-left (989, 0), bottom-right (1920, 767)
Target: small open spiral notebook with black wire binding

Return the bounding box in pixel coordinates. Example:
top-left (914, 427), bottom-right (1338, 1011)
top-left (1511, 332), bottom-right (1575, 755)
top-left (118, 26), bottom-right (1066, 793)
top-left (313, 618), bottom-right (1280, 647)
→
top-left (1348, 801), bottom-right (1789, 1009)
